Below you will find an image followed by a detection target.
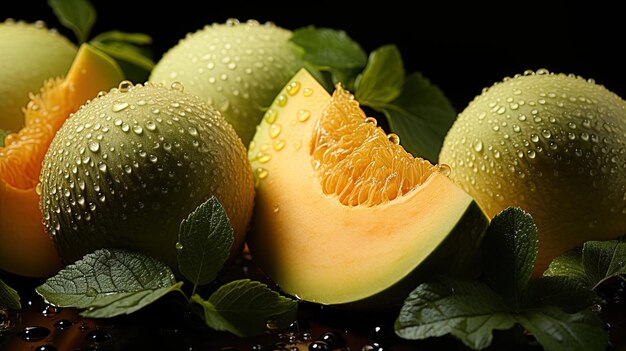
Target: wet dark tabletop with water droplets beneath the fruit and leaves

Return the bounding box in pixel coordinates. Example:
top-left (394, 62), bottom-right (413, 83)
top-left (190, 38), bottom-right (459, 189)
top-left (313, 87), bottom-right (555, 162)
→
top-left (0, 253), bottom-right (626, 351)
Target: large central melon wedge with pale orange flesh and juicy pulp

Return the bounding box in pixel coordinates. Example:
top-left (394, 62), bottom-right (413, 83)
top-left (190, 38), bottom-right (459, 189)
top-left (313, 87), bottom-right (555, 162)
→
top-left (248, 70), bottom-right (487, 304)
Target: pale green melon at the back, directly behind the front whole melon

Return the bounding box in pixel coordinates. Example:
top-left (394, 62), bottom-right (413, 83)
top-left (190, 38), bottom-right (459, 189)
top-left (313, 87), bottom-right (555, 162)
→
top-left (150, 19), bottom-right (301, 146)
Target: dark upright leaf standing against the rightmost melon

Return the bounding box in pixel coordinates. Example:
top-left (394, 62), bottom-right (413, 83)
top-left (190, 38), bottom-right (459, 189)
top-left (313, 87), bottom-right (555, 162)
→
top-left (481, 207), bottom-right (537, 306)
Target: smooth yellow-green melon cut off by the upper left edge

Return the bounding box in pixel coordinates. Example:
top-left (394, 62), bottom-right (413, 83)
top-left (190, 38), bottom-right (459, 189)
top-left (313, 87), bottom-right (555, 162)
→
top-left (0, 21), bottom-right (77, 131)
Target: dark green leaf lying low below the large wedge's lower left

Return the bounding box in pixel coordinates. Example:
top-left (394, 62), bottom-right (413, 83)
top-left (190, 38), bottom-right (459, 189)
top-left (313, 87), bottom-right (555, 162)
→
top-left (191, 279), bottom-right (298, 337)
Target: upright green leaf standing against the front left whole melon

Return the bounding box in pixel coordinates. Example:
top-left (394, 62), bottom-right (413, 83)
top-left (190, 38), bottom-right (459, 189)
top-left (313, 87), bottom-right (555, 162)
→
top-left (176, 196), bottom-right (234, 294)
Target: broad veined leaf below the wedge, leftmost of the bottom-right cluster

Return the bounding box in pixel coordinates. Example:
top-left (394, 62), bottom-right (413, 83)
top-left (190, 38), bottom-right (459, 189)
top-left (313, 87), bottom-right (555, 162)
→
top-left (395, 279), bottom-right (516, 349)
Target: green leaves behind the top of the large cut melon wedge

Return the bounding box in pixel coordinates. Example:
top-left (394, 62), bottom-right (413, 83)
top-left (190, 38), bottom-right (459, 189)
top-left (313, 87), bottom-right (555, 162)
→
top-left (290, 26), bottom-right (456, 163)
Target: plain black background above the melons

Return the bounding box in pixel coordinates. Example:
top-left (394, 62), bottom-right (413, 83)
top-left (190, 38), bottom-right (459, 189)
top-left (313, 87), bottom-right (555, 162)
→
top-left (0, 0), bottom-right (626, 110)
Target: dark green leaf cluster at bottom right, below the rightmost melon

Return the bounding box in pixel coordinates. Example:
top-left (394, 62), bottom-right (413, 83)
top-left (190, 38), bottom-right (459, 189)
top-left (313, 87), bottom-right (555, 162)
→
top-left (395, 208), bottom-right (626, 350)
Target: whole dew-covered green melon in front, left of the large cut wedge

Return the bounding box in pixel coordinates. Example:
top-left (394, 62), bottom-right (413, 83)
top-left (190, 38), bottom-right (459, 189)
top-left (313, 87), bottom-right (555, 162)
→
top-left (40, 81), bottom-right (254, 269)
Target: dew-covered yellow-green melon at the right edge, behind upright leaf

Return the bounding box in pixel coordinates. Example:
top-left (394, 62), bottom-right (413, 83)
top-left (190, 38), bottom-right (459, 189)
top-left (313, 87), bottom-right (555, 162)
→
top-left (439, 69), bottom-right (626, 274)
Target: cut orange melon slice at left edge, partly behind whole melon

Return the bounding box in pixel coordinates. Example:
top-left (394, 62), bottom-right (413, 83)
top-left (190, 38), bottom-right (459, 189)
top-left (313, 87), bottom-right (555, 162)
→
top-left (0, 44), bottom-right (123, 277)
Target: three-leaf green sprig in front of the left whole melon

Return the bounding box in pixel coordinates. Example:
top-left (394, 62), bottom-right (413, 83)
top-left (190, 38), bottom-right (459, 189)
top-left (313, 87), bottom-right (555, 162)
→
top-left (34, 197), bottom-right (297, 336)
